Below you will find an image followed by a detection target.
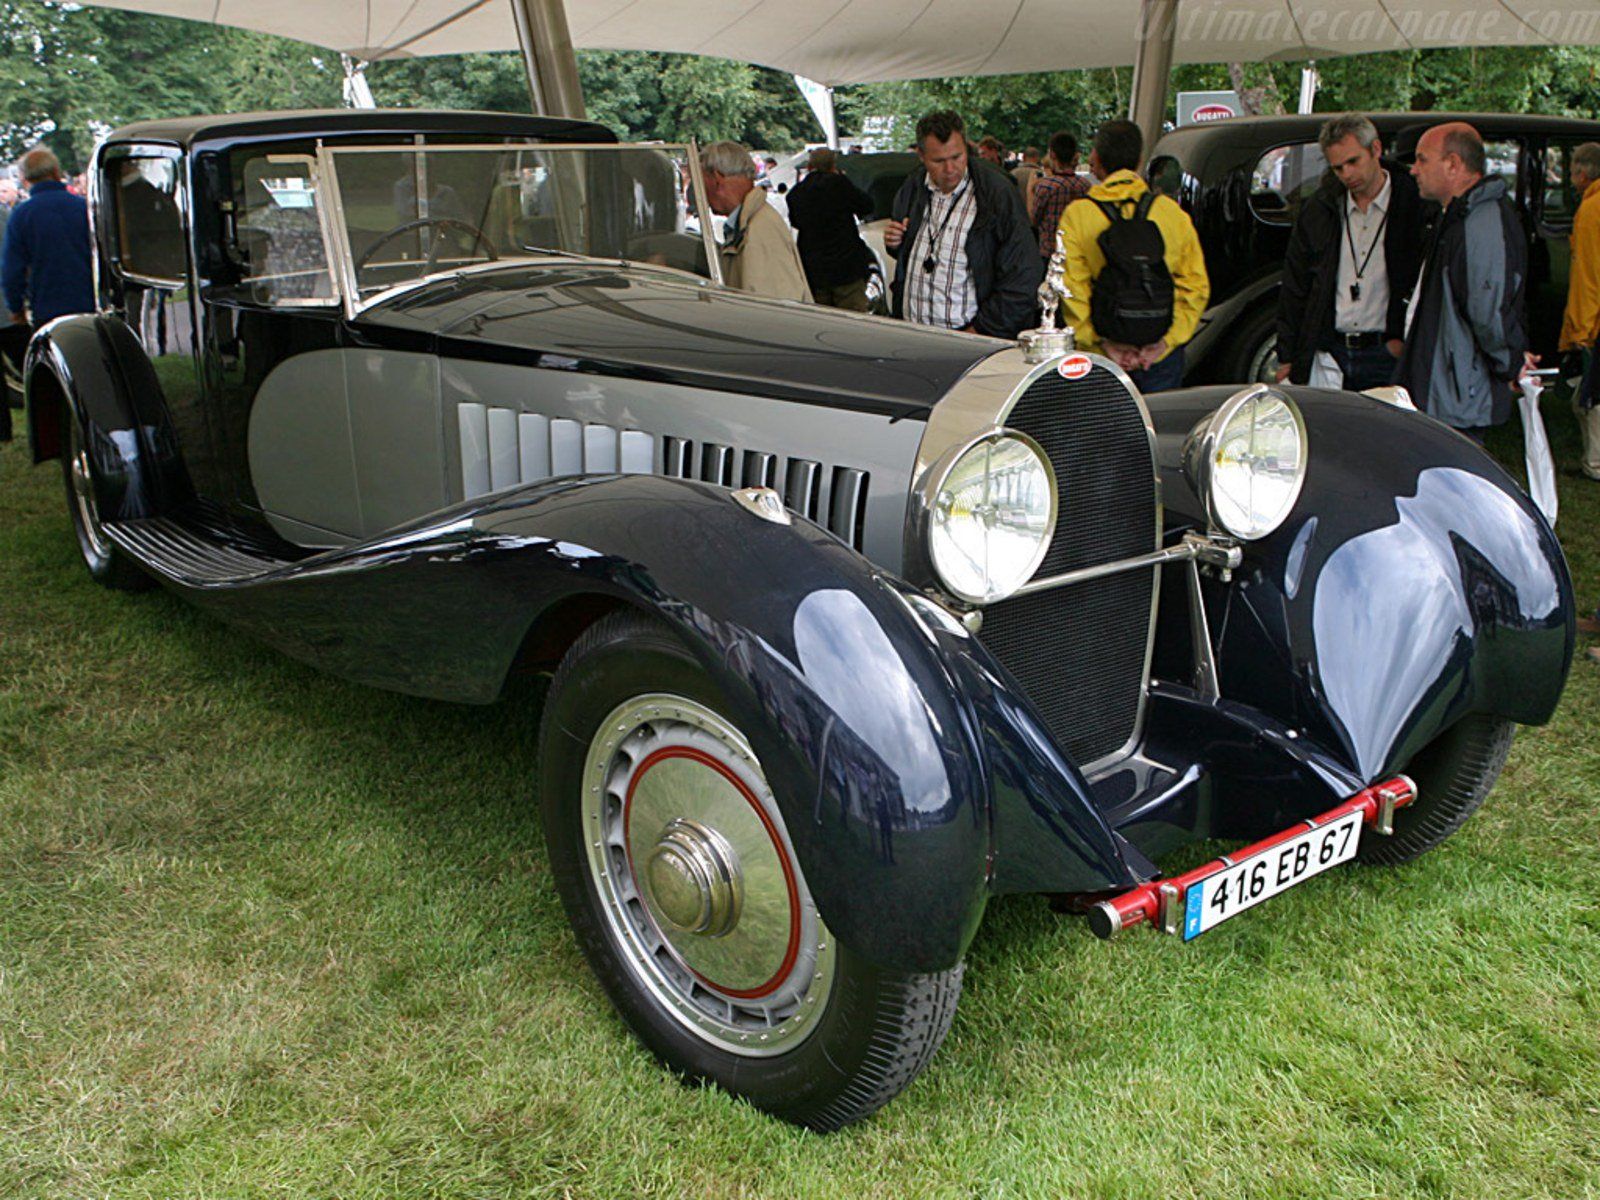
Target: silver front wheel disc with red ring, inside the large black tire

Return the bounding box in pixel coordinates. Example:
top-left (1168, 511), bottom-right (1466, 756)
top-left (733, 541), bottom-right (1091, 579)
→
top-left (582, 693), bottom-right (835, 1056)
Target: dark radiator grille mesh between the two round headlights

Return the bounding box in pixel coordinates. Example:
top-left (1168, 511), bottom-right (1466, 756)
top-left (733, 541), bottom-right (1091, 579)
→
top-left (981, 366), bottom-right (1160, 765)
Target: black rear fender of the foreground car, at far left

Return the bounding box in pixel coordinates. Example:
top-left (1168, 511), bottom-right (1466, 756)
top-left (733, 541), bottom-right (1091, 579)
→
top-left (24, 314), bottom-right (190, 522)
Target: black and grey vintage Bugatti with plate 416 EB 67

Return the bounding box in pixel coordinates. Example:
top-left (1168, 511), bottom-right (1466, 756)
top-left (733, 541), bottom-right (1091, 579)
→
top-left (26, 112), bottom-right (1574, 1128)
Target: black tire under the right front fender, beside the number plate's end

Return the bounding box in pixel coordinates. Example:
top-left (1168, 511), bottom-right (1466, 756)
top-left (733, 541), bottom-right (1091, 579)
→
top-left (1358, 712), bottom-right (1517, 867)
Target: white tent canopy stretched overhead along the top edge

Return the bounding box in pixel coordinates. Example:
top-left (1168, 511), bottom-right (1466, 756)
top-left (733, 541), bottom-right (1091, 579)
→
top-left (83, 0), bottom-right (1600, 85)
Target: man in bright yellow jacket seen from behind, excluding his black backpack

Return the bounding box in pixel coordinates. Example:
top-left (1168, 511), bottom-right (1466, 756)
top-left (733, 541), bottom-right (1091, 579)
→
top-left (1059, 120), bottom-right (1211, 392)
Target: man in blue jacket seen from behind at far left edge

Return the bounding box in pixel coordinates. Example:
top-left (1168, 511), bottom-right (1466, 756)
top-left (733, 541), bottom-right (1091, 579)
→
top-left (0, 147), bottom-right (94, 326)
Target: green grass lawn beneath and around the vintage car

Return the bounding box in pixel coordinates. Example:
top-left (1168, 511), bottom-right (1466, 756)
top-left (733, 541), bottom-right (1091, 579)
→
top-left (0, 402), bottom-right (1600, 1200)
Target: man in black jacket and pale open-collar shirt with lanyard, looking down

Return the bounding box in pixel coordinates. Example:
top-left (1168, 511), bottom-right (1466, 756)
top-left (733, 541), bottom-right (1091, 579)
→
top-left (1278, 114), bottom-right (1427, 392)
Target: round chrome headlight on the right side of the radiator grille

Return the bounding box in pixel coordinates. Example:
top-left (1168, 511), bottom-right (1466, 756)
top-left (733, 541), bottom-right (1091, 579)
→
top-left (1184, 384), bottom-right (1306, 541)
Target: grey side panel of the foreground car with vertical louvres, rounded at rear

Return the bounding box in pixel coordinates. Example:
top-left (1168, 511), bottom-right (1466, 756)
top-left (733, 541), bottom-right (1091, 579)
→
top-left (250, 347), bottom-right (925, 571)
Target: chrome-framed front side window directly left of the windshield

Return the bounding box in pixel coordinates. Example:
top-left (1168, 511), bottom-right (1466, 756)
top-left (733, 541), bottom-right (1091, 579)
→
top-left (237, 154), bottom-right (336, 306)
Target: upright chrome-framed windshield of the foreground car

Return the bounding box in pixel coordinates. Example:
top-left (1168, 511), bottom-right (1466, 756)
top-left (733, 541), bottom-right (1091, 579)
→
top-left (325, 146), bottom-right (709, 299)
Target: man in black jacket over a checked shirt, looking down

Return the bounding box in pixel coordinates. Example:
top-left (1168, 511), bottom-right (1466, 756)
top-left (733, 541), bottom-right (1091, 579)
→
top-left (883, 112), bottom-right (1045, 338)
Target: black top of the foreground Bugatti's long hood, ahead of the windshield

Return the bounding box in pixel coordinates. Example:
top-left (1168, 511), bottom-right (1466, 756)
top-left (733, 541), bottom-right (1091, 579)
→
top-left (357, 259), bottom-right (1011, 416)
